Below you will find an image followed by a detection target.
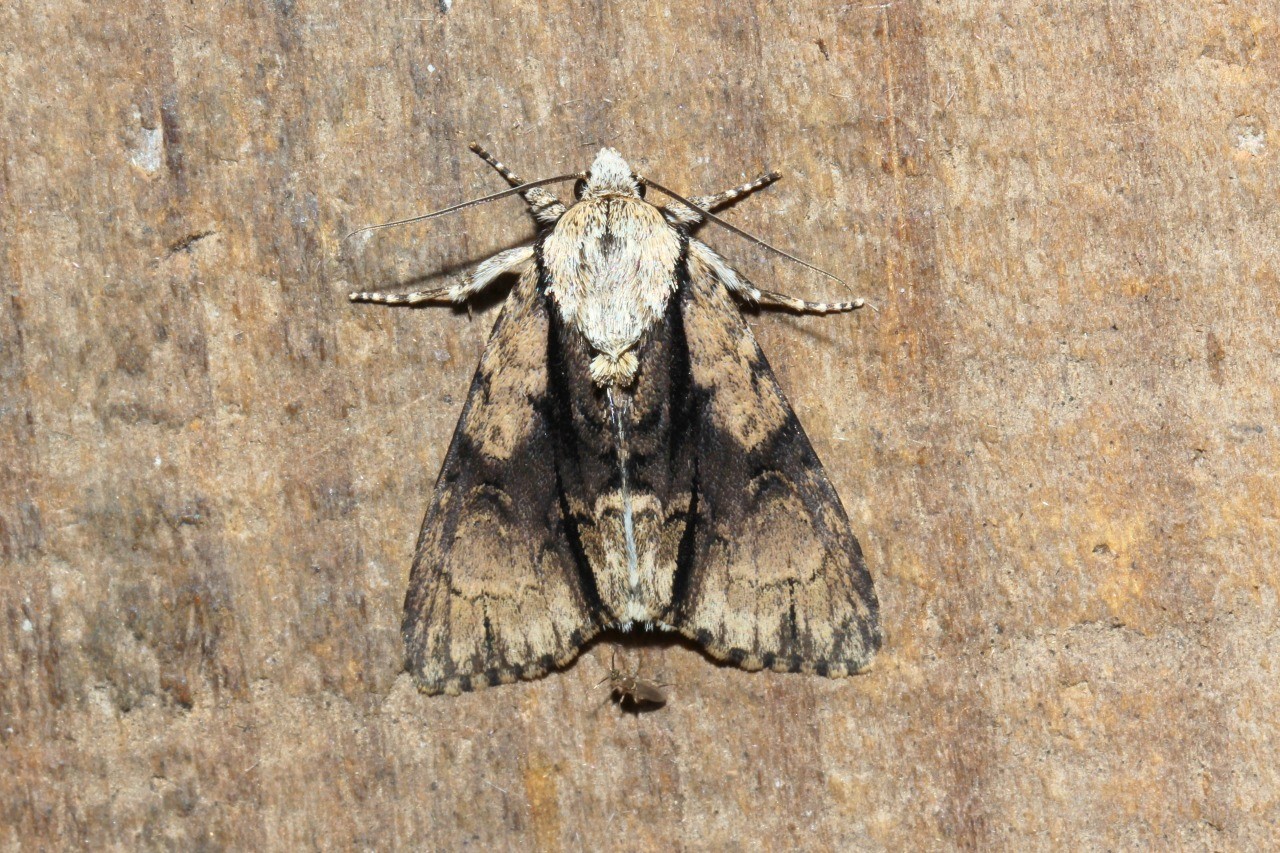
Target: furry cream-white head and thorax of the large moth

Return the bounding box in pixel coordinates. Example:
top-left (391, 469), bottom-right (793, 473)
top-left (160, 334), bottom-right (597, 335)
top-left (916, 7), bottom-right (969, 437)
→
top-left (543, 149), bottom-right (680, 386)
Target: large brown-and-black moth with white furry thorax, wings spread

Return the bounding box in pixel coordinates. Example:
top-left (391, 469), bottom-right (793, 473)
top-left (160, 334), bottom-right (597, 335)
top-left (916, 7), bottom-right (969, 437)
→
top-left (351, 145), bottom-right (881, 694)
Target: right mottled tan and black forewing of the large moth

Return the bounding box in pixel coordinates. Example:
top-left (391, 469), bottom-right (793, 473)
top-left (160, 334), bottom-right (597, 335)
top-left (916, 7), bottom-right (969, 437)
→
top-left (675, 251), bottom-right (881, 675)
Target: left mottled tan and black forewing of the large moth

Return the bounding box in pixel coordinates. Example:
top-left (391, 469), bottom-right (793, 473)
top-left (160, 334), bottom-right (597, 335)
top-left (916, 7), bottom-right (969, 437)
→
top-left (403, 265), bottom-right (598, 693)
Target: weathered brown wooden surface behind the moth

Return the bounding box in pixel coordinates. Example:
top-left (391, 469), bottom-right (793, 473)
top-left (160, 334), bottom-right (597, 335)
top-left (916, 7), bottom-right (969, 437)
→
top-left (0, 0), bottom-right (1280, 850)
